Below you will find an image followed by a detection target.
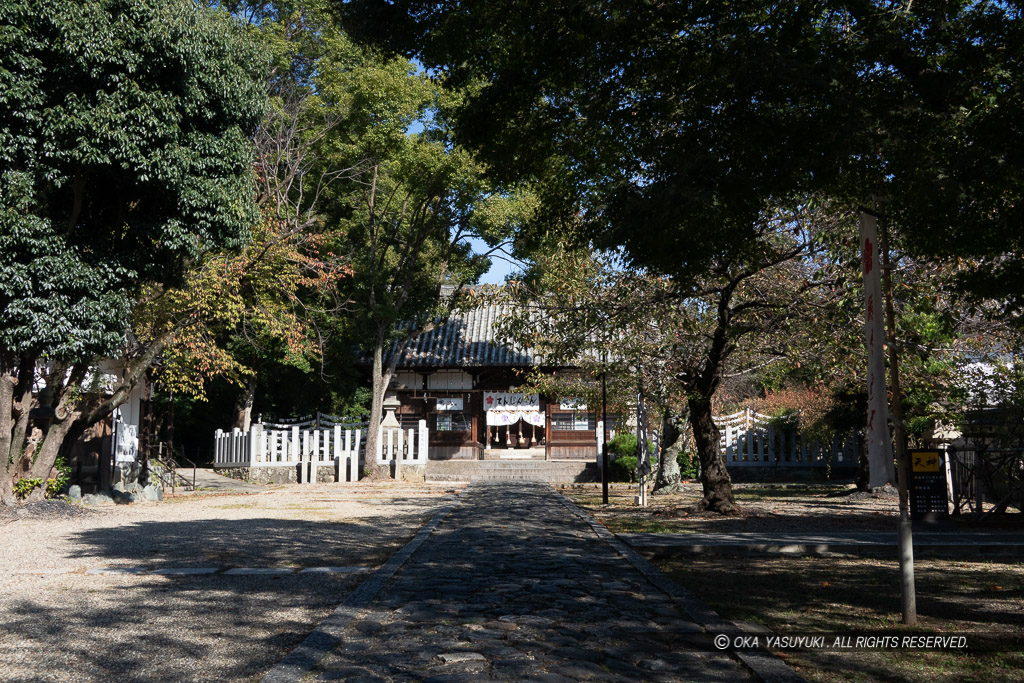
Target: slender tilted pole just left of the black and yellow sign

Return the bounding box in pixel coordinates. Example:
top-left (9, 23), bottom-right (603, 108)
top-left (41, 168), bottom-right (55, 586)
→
top-left (879, 204), bottom-right (918, 626)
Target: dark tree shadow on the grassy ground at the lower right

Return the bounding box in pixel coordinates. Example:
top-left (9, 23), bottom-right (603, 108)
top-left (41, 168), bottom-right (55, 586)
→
top-left (659, 555), bottom-right (1024, 681)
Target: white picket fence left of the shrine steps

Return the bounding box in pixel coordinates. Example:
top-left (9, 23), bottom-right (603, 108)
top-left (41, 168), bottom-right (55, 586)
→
top-left (213, 420), bottom-right (429, 483)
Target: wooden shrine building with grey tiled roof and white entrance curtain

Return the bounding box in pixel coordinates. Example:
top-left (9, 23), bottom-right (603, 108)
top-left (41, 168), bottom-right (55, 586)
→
top-left (393, 304), bottom-right (600, 461)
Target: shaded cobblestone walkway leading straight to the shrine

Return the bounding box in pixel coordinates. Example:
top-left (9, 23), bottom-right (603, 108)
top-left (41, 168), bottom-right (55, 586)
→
top-left (310, 482), bottom-right (750, 682)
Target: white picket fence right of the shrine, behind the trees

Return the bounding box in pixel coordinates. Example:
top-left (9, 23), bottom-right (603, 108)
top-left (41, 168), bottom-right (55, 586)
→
top-left (714, 409), bottom-right (859, 467)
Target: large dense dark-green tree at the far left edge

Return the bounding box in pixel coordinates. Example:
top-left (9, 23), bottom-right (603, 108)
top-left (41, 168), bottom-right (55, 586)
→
top-left (0, 0), bottom-right (265, 502)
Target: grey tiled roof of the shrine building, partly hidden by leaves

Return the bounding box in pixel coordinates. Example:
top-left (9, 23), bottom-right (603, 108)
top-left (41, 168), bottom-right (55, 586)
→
top-left (385, 304), bottom-right (543, 369)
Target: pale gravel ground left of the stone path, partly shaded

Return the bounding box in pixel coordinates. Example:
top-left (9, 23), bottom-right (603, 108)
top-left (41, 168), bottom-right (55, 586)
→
top-left (0, 483), bottom-right (464, 681)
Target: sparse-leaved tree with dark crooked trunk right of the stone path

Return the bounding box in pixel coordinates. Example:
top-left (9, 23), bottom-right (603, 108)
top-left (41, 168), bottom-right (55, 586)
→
top-left (493, 205), bottom-right (848, 513)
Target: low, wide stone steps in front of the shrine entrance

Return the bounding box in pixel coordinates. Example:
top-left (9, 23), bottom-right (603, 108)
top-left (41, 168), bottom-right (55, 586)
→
top-left (424, 460), bottom-right (600, 483)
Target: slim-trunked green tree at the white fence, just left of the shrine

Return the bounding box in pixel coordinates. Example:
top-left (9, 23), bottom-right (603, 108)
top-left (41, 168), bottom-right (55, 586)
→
top-left (335, 59), bottom-right (534, 464)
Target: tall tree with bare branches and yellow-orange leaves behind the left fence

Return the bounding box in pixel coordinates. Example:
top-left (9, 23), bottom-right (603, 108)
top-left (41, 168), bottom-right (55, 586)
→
top-left (205, 0), bottom-right (362, 429)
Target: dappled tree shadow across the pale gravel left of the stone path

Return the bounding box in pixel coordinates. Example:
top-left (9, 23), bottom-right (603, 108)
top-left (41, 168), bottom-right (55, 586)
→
top-left (0, 500), bottom-right (443, 681)
